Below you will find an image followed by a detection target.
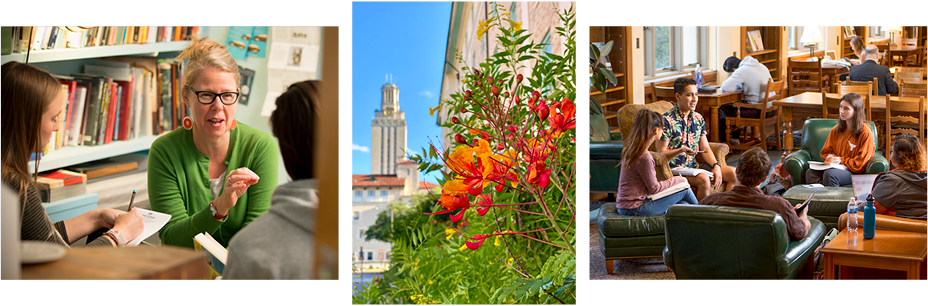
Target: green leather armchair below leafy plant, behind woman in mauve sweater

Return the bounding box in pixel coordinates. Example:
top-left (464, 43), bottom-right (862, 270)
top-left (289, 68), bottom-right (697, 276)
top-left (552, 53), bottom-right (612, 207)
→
top-left (590, 103), bottom-right (623, 193)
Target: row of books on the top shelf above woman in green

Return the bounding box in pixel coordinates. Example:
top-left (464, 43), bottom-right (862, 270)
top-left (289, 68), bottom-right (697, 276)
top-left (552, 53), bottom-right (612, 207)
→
top-left (0, 26), bottom-right (200, 55)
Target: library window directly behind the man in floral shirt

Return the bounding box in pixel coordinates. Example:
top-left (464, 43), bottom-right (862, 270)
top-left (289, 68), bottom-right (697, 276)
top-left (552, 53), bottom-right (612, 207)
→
top-left (644, 26), bottom-right (709, 77)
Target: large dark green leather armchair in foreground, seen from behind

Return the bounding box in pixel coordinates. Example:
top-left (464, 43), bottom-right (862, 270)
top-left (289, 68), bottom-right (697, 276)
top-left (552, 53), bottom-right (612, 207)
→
top-left (664, 204), bottom-right (825, 279)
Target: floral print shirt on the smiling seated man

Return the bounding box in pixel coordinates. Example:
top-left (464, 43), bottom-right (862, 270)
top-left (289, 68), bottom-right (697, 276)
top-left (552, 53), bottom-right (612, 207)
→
top-left (661, 105), bottom-right (706, 168)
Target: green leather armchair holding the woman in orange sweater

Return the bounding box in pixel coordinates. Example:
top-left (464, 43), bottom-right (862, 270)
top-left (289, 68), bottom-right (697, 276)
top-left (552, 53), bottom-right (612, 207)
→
top-left (783, 119), bottom-right (889, 186)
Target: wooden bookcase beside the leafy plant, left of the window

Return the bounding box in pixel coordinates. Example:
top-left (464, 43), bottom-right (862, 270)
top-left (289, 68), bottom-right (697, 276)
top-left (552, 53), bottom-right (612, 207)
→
top-left (590, 26), bottom-right (633, 126)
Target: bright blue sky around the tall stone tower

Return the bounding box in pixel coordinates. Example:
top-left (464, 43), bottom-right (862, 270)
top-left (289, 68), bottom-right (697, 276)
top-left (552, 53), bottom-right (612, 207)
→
top-left (351, 1), bottom-right (451, 182)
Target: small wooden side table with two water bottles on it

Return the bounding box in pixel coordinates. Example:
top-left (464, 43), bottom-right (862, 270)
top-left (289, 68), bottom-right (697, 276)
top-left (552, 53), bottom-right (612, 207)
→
top-left (822, 229), bottom-right (928, 279)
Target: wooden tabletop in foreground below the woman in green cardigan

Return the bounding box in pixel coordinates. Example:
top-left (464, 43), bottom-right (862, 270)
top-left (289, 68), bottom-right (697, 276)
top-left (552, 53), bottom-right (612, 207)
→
top-left (22, 245), bottom-right (207, 279)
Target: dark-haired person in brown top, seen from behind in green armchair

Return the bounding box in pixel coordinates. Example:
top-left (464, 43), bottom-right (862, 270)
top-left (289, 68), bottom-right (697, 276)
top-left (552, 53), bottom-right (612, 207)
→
top-left (699, 148), bottom-right (812, 240)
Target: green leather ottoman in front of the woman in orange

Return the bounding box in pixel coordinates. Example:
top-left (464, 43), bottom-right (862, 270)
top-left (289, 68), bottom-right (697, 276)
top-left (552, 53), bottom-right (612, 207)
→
top-left (783, 185), bottom-right (854, 232)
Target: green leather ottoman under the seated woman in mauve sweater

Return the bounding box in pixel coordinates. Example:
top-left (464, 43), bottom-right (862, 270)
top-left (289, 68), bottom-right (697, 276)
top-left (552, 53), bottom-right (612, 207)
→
top-left (596, 204), bottom-right (667, 274)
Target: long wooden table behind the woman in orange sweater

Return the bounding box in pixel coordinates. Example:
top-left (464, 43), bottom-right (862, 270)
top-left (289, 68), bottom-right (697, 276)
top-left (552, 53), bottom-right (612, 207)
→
top-left (773, 92), bottom-right (918, 160)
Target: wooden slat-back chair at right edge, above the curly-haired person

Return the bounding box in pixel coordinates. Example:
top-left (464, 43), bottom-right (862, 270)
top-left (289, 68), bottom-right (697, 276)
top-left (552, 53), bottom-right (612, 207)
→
top-left (883, 96), bottom-right (925, 169)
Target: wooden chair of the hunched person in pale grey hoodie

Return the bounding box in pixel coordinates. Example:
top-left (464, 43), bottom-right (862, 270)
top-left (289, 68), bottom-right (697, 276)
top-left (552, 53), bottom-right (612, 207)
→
top-left (725, 78), bottom-right (786, 151)
